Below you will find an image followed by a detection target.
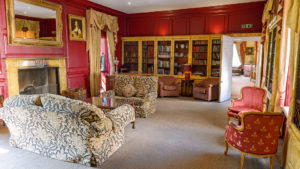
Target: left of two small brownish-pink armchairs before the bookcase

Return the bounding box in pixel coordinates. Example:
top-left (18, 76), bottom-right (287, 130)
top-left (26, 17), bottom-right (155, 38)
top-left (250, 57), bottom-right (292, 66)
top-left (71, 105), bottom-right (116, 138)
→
top-left (158, 76), bottom-right (179, 97)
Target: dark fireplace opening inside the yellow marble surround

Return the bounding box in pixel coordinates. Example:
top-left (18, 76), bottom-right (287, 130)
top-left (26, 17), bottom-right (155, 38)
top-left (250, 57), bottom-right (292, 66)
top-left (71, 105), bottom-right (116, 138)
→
top-left (18, 67), bottom-right (60, 95)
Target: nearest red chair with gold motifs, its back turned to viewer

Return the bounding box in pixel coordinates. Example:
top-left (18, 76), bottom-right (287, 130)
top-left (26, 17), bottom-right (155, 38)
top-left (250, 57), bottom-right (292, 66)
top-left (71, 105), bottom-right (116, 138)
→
top-left (224, 112), bottom-right (283, 169)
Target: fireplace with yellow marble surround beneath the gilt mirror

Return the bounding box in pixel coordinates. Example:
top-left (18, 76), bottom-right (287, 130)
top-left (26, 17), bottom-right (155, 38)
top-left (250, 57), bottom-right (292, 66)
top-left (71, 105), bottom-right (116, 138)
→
top-left (6, 57), bottom-right (67, 96)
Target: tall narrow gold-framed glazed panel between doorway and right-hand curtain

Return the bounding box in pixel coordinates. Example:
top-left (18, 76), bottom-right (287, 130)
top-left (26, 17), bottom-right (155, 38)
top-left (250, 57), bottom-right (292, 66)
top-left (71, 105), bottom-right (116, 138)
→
top-left (265, 27), bottom-right (277, 93)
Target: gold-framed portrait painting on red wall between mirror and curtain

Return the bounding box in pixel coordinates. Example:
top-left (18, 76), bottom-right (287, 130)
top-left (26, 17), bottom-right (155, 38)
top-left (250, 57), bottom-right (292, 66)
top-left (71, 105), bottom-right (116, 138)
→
top-left (69, 14), bottom-right (86, 41)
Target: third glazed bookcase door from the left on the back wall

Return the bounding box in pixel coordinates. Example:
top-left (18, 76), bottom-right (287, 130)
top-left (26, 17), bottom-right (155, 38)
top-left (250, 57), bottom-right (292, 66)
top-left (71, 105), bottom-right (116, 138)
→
top-left (157, 40), bottom-right (172, 75)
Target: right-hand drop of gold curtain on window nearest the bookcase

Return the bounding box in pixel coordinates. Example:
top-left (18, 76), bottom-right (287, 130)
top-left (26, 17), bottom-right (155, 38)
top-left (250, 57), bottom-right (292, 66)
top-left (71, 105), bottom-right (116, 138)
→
top-left (106, 31), bottom-right (116, 74)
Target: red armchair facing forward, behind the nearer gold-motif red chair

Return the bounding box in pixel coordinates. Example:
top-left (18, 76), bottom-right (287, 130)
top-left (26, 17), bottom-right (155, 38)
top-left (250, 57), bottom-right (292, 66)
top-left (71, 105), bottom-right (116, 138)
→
top-left (227, 86), bottom-right (266, 122)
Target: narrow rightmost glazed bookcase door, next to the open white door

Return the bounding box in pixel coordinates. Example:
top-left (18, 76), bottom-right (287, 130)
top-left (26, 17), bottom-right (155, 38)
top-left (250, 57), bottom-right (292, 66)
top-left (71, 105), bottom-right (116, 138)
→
top-left (210, 39), bottom-right (221, 77)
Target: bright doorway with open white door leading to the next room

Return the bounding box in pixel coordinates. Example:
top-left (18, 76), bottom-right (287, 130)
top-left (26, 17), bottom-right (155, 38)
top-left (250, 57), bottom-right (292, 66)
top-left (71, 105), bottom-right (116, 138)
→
top-left (219, 35), bottom-right (261, 102)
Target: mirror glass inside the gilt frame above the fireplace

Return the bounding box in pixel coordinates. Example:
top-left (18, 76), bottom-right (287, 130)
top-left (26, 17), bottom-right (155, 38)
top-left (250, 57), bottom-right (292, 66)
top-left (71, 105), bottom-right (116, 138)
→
top-left (14, 0), bottom-right (56, 41)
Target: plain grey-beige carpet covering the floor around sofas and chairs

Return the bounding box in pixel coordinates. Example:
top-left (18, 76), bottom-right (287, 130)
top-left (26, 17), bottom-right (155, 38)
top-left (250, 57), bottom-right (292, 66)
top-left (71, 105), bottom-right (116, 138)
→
top-left (0, 97), bottom-right (280, 169)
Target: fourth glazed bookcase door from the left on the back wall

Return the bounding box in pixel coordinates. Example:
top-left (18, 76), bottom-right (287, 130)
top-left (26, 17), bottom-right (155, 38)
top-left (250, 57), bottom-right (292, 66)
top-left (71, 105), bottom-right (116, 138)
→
top-left (174, 40), bottom-right (189, 75)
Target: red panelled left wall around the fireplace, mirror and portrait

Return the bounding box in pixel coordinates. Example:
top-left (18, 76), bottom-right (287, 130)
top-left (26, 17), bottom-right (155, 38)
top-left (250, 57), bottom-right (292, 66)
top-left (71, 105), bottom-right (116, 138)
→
top-left (0, 0), bottom-right (125, 97)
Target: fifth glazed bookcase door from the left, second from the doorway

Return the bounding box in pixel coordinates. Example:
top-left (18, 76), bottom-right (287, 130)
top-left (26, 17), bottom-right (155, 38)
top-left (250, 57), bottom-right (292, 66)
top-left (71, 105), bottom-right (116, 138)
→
top-left (192, 40), bottom-right (208, 77)
